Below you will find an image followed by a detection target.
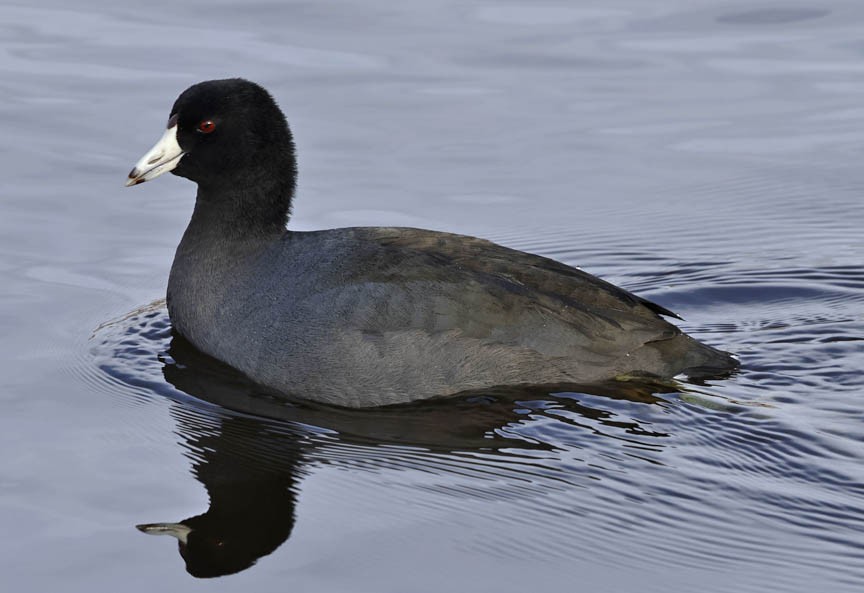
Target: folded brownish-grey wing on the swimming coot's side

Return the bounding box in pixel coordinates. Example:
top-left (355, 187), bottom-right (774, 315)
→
top-left (298, 227), bottom-right (681, 356)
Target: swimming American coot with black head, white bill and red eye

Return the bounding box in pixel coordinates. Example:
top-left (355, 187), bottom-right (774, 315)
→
top-left (127, 79), bottom-right (737, 407)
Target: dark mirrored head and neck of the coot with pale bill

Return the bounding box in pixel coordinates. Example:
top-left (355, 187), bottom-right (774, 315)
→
top-left (138, 413), bottom-right (299, 577)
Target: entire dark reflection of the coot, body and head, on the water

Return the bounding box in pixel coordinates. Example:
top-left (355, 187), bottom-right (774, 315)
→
top-left (138, 335), bottom-right (668, 577)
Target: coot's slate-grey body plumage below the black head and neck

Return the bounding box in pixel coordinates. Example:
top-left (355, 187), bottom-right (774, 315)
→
top-left (168, 227), bottom-right (728, 406)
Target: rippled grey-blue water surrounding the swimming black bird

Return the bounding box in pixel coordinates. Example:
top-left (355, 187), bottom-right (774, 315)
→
top-left (0, 0), bottom-right (864, 592)
